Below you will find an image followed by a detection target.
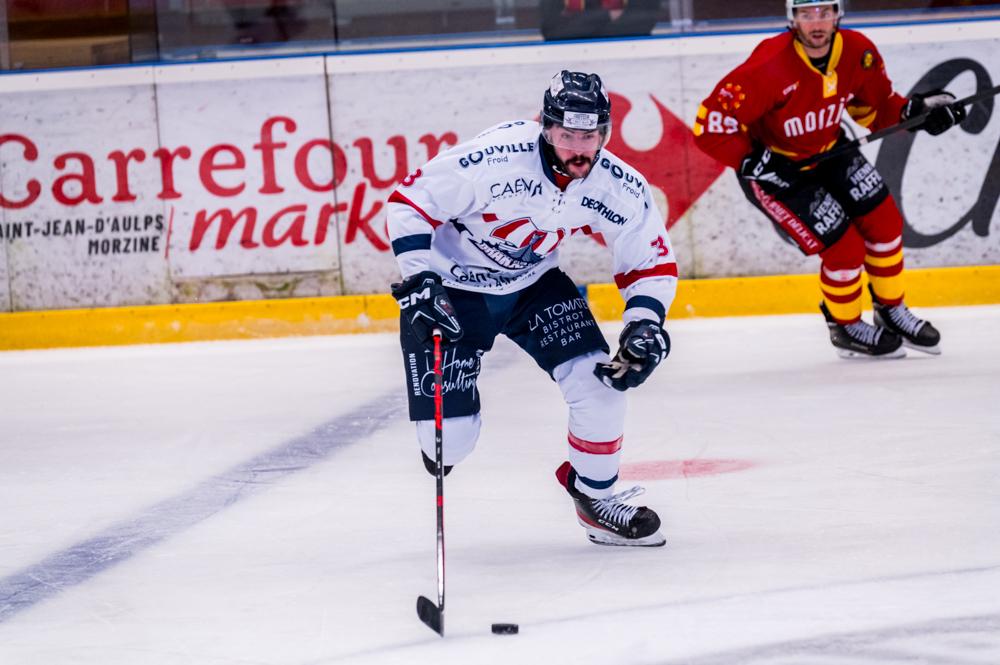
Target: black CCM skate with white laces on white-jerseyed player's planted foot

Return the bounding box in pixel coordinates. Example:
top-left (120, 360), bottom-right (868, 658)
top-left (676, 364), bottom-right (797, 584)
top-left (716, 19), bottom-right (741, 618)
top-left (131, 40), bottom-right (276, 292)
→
top-left (556, 462), bottom-right (667, 547)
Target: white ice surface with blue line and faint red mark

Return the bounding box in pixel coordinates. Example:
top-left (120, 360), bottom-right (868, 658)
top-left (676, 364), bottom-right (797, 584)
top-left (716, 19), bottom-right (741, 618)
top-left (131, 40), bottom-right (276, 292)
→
top-left (0, 307), bottom-right (1000, 665)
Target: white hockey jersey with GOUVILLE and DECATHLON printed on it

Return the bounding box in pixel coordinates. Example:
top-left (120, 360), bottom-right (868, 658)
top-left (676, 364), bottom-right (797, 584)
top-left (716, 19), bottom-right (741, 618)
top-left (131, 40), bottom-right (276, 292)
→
top-left (388, 120), bottom-right (677, 321)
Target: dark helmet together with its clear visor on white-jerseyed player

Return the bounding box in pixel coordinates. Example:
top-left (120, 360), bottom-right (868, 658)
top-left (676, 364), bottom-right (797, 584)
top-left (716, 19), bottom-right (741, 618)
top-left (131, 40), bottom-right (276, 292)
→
top-left (542, 70), bottom-right (611, 152)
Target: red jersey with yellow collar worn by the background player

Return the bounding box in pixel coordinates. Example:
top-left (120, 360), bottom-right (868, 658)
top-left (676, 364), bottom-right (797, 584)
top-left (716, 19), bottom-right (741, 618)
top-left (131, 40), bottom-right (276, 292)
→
top-left (694, 30), bottom-right (906, 169)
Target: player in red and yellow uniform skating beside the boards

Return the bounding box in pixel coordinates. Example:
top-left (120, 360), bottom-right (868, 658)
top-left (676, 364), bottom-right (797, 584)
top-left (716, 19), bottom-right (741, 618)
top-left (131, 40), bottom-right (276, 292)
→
top-left (694, 0), bottom-right (965, 358)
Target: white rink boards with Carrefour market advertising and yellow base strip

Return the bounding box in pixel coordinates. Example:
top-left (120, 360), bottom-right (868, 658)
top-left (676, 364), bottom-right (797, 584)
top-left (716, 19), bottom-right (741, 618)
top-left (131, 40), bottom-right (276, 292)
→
top-left (0, 20), bottom-right (1000, 348)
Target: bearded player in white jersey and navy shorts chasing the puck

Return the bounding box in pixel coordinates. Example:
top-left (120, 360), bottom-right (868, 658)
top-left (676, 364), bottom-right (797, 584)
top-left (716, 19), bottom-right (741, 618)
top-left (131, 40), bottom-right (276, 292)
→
top-left (388, 71), bottom-right (677, 546)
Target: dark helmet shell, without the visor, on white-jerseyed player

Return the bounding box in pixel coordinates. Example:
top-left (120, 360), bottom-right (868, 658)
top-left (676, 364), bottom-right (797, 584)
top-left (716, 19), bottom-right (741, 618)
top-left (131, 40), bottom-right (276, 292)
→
top-left (542, 69), bottom-right (611, 134)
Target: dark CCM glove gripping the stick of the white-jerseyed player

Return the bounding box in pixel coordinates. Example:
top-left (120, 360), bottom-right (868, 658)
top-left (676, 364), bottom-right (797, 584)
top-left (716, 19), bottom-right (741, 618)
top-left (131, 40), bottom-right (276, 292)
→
top-left (392, 270), bottom-right (462, 348)
